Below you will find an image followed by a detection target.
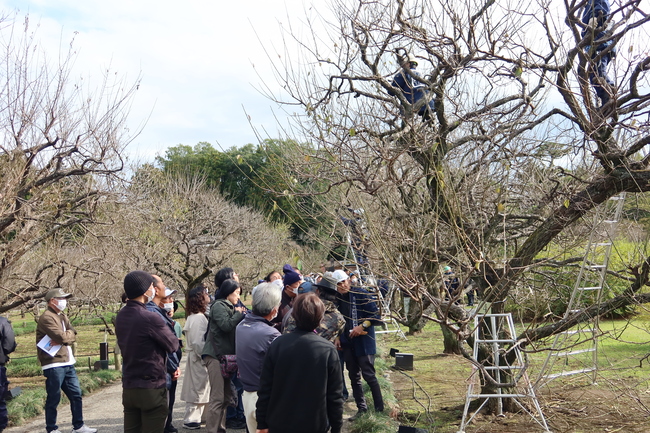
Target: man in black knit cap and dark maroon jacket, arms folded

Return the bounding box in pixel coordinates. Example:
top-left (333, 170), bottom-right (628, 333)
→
top-left (115, 271), bottom-right (179, 433)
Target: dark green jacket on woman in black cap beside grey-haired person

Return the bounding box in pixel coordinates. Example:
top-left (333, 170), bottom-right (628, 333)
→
top-left (202, 299), bottom-right (244, 359)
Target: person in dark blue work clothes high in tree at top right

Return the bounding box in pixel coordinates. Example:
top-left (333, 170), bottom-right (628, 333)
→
top-left (582, 0), bottom-right (616, 106)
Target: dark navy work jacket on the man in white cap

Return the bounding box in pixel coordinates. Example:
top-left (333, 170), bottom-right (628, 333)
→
top-left (338, 287), bottom-right (382, 356)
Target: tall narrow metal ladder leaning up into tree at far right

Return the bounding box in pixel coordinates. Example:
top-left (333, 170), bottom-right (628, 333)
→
top-left (537, 193), bottom-right (625, 385)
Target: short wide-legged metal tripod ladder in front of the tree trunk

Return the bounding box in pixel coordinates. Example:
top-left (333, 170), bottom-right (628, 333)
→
top-left (458, 313), bottom-right (550, 433)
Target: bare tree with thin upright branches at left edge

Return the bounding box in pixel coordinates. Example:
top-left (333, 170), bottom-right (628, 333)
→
top-left (0, 16), bottom-right (138, 311)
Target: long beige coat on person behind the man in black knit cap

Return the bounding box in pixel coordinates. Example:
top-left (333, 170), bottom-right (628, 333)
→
top-left (181, 313), bottom-right (210, 404)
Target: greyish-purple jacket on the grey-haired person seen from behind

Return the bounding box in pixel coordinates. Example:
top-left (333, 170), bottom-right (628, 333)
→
top-left (235, 313), bottom-right (280, 392)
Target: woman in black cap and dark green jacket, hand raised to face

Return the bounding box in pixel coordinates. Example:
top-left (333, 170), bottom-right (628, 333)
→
top-left (202, 279), bottom-right (246, 433)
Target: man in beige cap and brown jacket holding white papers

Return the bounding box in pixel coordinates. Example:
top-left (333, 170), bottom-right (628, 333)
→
top-left (36, 288), bottom-right (97, 433)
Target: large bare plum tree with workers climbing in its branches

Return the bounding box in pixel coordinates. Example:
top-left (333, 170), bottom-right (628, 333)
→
top-left (256, 0), bottom-right (650, 412)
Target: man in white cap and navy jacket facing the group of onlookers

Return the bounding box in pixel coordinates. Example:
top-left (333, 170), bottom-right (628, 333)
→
top-left (332, 269), bottom-right (384, 421)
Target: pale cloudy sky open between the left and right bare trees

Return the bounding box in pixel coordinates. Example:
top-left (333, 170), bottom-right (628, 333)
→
top-left (0, 0), bottom-right (314, 159)
